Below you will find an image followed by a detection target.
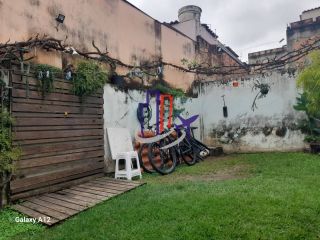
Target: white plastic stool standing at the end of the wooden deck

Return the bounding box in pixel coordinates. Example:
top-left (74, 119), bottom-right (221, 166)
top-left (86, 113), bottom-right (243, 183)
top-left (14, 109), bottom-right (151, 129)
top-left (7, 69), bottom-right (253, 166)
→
top-left (115, 151), bottom-right (142, 180)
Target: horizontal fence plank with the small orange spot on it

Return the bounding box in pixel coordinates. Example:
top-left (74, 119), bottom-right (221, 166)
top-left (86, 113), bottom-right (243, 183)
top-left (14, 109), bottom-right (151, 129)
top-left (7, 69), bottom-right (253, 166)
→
top-left (12, 103), bottom-right (103, 115)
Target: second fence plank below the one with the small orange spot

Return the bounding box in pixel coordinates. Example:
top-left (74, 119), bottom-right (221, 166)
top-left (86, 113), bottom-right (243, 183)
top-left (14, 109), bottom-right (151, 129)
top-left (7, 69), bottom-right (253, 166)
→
top-left (14, 129), bottom-right (103, 141)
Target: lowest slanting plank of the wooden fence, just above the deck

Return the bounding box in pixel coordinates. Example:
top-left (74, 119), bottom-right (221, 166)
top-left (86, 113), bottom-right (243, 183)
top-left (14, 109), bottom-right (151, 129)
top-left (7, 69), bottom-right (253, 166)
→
top-left (10, 171), bottom-right (103, 201)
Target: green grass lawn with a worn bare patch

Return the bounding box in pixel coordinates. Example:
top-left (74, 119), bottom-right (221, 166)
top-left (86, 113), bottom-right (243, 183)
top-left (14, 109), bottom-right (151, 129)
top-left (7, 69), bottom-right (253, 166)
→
top-left (0, 153), bottom-right (320, 240)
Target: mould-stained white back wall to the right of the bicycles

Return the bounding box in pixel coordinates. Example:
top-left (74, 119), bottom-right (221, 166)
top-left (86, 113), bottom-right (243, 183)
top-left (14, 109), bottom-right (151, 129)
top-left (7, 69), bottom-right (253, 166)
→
top-left (188, 73), bottom-right (304, 152)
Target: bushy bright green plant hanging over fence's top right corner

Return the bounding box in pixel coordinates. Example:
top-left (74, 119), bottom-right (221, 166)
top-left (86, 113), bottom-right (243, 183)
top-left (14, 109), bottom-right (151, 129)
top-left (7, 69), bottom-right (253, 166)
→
top-left (73, 60), bottom-right (108, 97)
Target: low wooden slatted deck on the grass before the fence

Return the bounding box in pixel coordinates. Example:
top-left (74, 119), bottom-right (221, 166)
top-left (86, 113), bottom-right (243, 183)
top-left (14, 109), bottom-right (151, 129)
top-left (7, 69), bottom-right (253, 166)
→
top-left (12, 177), bottom-right (144, 226)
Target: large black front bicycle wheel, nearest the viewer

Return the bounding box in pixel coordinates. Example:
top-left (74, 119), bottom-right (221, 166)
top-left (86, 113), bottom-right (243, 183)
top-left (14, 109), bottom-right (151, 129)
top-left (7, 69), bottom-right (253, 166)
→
top-left (148, 139), bottom-right (177, 175)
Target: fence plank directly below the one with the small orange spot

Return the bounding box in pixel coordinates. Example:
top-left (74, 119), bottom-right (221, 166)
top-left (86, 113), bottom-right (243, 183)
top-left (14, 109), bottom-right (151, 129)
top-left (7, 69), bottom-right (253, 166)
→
top-left (14, 117), bottom-right (103, 127)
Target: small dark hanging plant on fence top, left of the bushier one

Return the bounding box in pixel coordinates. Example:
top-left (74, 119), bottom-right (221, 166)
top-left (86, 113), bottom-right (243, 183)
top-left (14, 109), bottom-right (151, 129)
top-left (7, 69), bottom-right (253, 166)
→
top-left (35, 64), bottom-right (62, 97)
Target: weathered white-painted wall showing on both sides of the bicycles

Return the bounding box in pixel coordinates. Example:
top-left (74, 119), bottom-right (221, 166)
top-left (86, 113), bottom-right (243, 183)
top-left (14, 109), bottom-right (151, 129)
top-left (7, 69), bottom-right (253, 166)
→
top-left (104, 73), bottom-right (305, 169)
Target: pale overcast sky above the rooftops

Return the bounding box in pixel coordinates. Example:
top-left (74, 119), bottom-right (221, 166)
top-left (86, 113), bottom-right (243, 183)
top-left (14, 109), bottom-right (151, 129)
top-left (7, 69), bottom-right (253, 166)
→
top-left (129, 0), bottom-right (320, 61)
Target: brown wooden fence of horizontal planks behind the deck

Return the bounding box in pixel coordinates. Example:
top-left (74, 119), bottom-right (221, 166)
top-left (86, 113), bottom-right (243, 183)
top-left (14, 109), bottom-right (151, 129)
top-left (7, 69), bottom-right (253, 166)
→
top-left (10, 72), bottom-right (104, 200)
